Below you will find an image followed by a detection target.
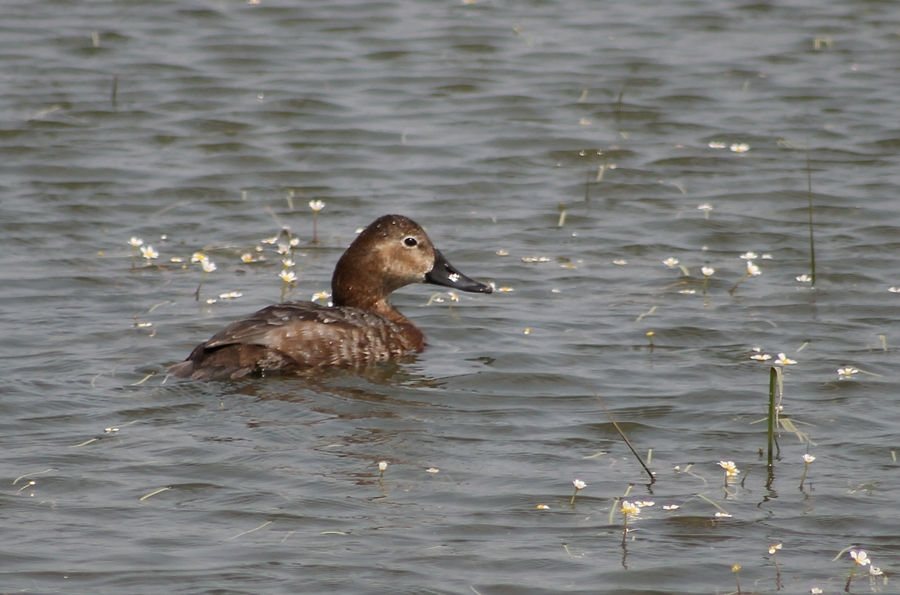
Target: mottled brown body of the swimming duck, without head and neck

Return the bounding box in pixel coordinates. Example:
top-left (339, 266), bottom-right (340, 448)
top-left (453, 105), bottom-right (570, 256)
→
top-left (170, 302), bottom-right (424, 380)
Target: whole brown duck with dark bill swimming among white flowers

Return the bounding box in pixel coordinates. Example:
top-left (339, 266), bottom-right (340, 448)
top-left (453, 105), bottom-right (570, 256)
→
top-left (168, 215), bottom-right (492, 380)
